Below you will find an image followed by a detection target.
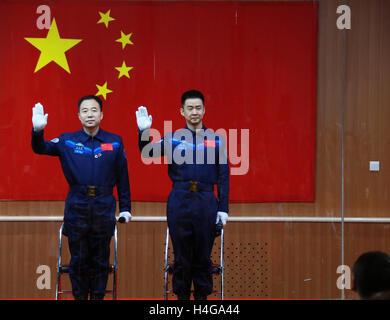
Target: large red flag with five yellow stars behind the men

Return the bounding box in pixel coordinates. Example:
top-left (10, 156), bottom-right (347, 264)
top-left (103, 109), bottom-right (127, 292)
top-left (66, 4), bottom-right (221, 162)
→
top-left (0, 0), bottom-right (318, 202)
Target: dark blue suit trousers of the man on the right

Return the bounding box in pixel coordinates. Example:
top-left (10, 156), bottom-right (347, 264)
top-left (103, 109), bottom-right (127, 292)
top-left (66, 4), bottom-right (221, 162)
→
top-left (167, 188), bottom-right (218, 298)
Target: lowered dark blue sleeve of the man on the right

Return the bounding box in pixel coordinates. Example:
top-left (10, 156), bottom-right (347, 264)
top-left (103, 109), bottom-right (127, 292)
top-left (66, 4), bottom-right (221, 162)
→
top-left (217, 136), bottom-right (230, 213)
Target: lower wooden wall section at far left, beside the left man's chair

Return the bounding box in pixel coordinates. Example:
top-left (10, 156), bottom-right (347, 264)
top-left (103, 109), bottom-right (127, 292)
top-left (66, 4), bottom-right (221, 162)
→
top-left (0, 222), bottom-right (59, 299)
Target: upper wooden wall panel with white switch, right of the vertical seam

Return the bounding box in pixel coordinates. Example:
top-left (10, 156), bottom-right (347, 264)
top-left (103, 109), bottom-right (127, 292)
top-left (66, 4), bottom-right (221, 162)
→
top-left (345, 0), bottom-right (390, 217)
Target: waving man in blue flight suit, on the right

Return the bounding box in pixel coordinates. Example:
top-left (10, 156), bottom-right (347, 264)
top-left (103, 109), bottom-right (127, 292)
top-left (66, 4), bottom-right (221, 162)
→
top-left (136, 90), bottom-right (229, 300)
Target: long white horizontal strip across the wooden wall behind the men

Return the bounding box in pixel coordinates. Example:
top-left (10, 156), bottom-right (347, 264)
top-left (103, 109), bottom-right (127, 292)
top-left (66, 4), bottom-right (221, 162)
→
top-left (0, 216), bottom-right (390, 223)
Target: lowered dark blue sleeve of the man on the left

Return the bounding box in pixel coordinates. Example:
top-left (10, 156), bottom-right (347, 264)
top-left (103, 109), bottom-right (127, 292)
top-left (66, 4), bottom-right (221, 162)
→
top-left (116, 140), bottom-right (131, 212)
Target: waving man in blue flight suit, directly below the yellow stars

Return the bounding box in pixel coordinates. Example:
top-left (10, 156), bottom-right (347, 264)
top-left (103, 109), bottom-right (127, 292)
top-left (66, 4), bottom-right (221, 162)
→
top-left (31, 95), bottom-right (131, 300)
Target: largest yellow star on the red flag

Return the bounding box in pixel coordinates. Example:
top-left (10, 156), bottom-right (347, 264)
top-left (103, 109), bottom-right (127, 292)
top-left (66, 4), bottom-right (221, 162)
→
top-left (24, 18), bottom-right (82, 73)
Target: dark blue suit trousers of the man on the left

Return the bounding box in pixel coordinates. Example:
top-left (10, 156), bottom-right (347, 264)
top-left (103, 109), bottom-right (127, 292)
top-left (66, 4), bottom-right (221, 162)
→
top-left (64, 190), bottom-right (116, 296)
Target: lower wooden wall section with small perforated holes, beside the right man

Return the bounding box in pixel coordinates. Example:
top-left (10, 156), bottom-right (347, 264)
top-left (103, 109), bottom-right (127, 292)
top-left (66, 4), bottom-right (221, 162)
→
top-left (221, 222), bottom-right (341, 299)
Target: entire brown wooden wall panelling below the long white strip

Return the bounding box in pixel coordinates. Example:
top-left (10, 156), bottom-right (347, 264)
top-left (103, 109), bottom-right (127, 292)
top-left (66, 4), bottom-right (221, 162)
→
top-left (0, 222), bottom-right (390, 299)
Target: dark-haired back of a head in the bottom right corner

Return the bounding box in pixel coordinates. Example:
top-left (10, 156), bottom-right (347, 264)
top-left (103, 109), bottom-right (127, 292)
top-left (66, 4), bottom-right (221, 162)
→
top-left (353, 251), bottom-right (390, 299)
